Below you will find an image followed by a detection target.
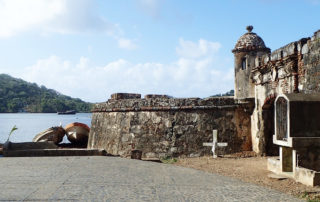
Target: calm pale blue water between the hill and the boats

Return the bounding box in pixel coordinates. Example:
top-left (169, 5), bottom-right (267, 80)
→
top-left (0, 113), bottom-right (91, 143)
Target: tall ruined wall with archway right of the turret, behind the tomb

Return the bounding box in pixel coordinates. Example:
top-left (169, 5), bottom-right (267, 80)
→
top-left (251, 30), bottom-right (320, 154)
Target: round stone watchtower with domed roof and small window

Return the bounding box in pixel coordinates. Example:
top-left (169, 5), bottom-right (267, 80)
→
top-left (232, 25), bottom-right (270, 99)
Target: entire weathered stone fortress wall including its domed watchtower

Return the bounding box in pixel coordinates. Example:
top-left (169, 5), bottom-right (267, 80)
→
top-left (88, 26), bottom-right (320, 161)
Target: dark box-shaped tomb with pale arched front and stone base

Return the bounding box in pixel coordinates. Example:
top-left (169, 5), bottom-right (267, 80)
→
top-left (268, 93), bottom-right (320, 186)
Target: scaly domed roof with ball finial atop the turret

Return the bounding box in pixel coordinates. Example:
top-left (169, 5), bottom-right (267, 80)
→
top-left (232, 25), bottom-right (270, 53)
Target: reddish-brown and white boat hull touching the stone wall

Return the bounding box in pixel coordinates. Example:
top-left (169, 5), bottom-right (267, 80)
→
top-left (65, 122), bottom-right (90, 144)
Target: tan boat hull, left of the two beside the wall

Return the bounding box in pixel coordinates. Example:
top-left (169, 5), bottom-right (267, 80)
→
top-left (32, 127), bottom-right (66, 144)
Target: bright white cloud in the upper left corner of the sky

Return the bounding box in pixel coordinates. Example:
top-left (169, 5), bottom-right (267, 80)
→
top-left (0, 0), bottom-right (136, 50)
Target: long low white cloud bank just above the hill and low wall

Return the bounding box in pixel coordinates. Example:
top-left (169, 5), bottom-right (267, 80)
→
top-left (14, 40), bottom-right (233, 102)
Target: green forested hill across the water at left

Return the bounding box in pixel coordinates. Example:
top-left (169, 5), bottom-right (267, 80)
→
top-left (0, 74), bottom-right (92, 113)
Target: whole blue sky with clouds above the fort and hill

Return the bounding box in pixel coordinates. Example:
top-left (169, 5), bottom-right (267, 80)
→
top-left (0, 0), bottom-right (320, 102)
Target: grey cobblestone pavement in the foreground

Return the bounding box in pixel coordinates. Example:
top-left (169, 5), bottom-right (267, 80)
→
top-left (0, 156), bottom-right (298, 202)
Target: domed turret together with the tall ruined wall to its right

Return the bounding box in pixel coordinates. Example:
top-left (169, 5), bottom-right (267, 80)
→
top-left (232, 26), bottom-right (320, 155)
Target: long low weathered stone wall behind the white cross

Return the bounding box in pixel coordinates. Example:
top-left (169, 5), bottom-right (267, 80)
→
top-left (88, 95), bottom-right (252, 158)
